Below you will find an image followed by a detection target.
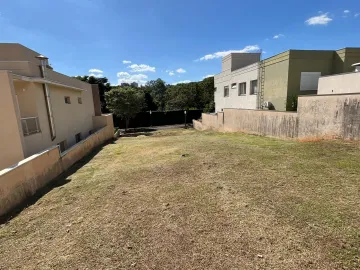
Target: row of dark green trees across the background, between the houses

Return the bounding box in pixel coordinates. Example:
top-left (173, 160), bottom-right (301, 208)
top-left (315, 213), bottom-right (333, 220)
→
top-left (75, 76), bottom-right (215, 128)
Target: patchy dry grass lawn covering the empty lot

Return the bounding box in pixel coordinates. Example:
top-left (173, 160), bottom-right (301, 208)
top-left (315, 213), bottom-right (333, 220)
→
top-left (0, 129), bottom-right (360, 270)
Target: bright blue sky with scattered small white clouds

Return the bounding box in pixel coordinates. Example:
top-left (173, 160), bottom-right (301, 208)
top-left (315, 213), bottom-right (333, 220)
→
top-left (0, 0), bottom-right (360, 84)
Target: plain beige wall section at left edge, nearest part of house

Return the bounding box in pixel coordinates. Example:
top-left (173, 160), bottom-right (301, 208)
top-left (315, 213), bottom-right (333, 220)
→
top-left (0, 71), bottom-right (24, 169)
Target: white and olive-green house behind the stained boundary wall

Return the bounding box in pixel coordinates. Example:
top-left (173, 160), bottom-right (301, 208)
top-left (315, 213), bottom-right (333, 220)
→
top-left (215, 48), bottom-right (360, 112)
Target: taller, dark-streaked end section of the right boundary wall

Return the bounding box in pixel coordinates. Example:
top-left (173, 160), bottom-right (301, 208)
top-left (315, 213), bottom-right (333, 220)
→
top-left (298, 94), bottom-right (360, 140)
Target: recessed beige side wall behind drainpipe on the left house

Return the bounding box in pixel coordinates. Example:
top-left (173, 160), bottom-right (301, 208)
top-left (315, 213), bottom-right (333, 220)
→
top-left (14, 82), bottom-right (95, 157)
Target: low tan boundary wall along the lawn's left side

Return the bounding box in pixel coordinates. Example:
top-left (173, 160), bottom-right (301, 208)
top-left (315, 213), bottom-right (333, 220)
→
top-left (0, 115), bottom-right (114, 216)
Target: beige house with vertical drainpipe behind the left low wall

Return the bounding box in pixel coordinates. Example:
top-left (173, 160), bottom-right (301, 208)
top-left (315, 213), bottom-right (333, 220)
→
top-left (0, 43), bottom-right (101, 170)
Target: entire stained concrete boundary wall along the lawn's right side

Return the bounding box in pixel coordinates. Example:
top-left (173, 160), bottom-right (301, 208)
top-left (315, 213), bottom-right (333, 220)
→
top-left (194, 94), bottom-right (360, 140)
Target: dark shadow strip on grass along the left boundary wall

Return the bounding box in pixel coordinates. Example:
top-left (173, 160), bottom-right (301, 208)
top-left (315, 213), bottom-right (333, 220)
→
top-left (0, 144), bottom-right (106, 225)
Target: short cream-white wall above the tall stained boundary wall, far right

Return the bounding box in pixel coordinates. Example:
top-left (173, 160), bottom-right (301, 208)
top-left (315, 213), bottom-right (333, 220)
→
top-left (318, 72), bottom-right (360, 95)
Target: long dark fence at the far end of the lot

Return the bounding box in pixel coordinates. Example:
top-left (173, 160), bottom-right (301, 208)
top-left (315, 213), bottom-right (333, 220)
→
top-left (114, 110), bottom-right (202, 129)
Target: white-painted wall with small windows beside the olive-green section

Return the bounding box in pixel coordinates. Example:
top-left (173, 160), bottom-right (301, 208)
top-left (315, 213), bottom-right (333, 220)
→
top-left (214, 63), bottom-right (259, 112)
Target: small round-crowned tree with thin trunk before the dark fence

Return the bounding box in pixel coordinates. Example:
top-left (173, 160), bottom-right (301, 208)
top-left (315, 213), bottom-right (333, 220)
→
top-left (105, 86), bottom-right (145, 131)
